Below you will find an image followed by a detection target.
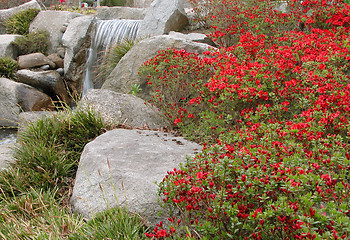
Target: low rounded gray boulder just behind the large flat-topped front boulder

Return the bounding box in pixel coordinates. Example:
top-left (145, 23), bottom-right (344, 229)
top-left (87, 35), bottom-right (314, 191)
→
top-left (79, 89), bottom-right (169, 129)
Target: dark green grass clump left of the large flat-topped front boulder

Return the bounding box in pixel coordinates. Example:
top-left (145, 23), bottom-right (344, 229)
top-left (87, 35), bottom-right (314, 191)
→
top-left (0, 109), bottom-right (105, 199)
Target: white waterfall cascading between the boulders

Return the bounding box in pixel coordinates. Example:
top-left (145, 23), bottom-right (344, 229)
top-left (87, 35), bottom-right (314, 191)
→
top-left (82, 19), bottom-right (141, 95)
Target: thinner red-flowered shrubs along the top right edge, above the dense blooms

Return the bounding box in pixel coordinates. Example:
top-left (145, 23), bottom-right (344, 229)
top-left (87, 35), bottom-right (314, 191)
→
top-left (191, 0), bottom-right (350, 47)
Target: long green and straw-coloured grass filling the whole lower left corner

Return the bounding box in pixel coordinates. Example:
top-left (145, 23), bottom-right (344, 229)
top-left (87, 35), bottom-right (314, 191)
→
top-left (0, 108), bottom-right (146, 240)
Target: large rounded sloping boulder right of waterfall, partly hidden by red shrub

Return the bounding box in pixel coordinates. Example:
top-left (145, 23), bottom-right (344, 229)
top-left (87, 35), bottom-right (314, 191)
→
top-left (102, 35), bottom-right (210, 99)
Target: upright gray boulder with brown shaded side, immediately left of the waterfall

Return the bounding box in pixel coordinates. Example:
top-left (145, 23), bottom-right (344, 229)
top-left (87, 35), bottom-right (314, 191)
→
top-left (62, 16), bottom-right (93, 92)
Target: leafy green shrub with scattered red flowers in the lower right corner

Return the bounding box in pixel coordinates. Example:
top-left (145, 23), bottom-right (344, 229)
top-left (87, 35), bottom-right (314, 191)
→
top-left (160, 121), bottom-right (350, 239)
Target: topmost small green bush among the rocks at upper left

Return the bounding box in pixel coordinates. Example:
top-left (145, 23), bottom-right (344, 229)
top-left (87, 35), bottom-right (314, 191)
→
top-left (5, 8), bottom-right (40, 35)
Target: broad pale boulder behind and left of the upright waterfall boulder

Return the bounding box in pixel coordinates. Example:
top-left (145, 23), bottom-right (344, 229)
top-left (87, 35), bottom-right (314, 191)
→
top-left (29, 10), bottom-right (82, 54)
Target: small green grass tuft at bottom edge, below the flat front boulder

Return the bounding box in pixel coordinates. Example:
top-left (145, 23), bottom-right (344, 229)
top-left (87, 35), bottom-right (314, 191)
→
top-left (68, 207), bottom-right (147, 240)
